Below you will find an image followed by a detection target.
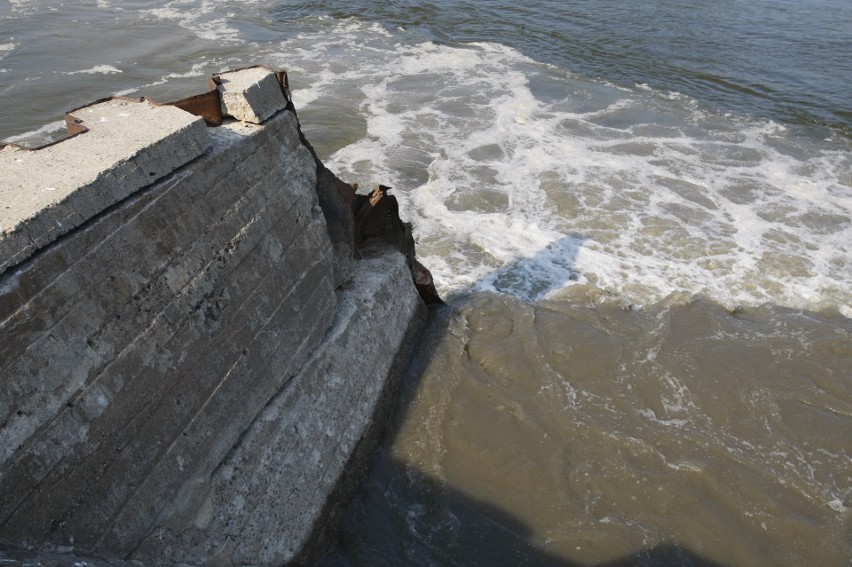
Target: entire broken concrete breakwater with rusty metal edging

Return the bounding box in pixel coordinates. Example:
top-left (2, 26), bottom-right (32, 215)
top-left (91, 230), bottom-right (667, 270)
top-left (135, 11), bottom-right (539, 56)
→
top-left (0, 67), bottom-right (440, 565)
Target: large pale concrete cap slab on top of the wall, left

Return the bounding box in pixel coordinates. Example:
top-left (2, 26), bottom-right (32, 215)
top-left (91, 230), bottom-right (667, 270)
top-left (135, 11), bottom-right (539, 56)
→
top-left (0, 99), bottom-right (209, 273)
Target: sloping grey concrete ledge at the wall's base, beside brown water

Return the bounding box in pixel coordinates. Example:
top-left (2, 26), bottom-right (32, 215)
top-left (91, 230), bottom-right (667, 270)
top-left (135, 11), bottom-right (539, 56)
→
top-left (132, 251), bottom-right (425, 565)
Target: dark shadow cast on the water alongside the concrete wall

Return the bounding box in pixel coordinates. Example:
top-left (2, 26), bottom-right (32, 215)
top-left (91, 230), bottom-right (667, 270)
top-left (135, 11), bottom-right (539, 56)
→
top-left (319, 236), bottom-right (736, 567)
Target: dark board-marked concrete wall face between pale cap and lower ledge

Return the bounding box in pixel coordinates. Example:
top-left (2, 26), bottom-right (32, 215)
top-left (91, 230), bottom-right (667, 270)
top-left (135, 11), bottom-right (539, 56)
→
top-left (0, 107), bottom-right (337, 556)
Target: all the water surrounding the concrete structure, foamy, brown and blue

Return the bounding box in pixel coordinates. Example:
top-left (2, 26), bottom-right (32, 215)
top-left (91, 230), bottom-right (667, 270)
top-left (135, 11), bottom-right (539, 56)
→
top-left (0, 0), bottom-right (852, 567)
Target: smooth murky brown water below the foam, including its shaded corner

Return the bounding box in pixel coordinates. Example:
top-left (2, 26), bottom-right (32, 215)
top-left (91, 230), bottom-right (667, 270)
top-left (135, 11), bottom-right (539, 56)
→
top-left (322, 292), bottom-right (852, 566)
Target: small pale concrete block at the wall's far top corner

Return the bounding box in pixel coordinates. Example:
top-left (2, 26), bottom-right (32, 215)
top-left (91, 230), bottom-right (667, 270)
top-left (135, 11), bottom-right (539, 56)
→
top-left (218, 67), bottom-right (287, 124)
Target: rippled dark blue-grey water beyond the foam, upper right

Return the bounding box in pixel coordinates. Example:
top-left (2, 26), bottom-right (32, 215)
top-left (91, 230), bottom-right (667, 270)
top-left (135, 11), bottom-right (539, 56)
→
top-left (282, 0), bottom-right (852, 135)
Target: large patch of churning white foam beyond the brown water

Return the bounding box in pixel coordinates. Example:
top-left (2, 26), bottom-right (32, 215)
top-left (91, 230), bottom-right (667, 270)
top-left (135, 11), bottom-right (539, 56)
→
top-left (280, 20), bottom-right (852, 316)
